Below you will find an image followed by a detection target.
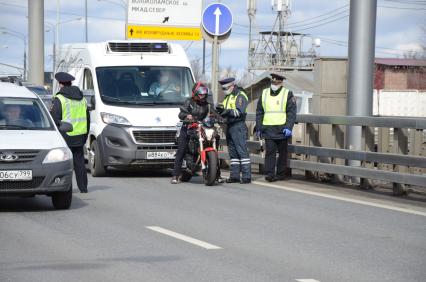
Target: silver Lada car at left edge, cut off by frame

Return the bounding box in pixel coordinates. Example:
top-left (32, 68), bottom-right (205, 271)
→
top-left (0, 82), bottom-right (73, 209)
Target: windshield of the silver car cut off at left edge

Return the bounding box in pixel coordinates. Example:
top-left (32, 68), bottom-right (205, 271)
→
top-left (0, 97), bottom-right (54, 130)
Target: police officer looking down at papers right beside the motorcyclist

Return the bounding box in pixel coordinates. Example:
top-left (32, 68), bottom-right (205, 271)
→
top-left (216, 77), bottom-right (251, 184)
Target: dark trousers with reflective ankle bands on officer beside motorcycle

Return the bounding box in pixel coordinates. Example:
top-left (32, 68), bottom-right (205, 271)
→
top-left (226, 121), bottom-right (251, 179)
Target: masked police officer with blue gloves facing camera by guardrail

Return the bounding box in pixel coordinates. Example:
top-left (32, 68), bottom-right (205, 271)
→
top-left (256, 73), bottom-right (296, 182)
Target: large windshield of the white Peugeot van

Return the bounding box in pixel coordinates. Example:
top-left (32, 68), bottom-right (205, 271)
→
top-left (96, 66), bottom-right (194, 105)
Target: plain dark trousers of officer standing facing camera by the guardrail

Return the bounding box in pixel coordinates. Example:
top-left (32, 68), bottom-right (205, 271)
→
top-left (265, 139), bottom-right (288, 177)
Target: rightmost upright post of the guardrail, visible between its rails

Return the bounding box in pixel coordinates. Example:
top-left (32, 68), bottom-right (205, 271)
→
top-left (392, 128), bottom-right (408, 196)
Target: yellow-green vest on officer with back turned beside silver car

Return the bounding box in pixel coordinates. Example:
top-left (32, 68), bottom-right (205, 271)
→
top-left (56, 93), bottom-right (87, 136)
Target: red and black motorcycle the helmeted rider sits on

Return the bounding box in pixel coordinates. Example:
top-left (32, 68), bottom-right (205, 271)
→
top-left (176, 117), bottom-right (219, 186)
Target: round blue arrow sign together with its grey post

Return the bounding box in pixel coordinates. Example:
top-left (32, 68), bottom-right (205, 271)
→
top-left (202, 3), bottom-right (233, 104)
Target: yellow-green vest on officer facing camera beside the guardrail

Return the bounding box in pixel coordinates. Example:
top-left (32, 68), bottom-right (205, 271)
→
top-left (262, 87), bottom-right (289, 125)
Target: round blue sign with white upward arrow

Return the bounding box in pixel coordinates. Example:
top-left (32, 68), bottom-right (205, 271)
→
top-left (202, 3), bottom-right (233, 36)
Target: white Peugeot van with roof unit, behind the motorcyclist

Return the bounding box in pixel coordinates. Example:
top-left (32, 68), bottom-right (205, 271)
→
top-left (53, 40), bottom-right (194, 176)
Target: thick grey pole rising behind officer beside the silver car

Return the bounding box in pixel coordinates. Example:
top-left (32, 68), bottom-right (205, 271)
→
top-left (28, 0), bottom-right (44, 85)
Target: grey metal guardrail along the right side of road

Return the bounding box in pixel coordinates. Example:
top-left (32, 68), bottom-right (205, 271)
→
top-left (221, 113), bottom-right (426, 194)
